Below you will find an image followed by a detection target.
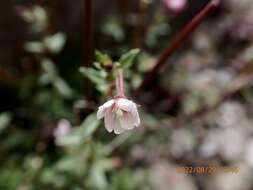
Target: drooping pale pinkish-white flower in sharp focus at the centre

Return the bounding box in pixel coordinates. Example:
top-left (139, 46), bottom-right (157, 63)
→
top-left (97, 98), bottom-right (140, 134)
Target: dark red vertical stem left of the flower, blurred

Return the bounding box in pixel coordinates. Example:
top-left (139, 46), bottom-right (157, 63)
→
top-left (84, 0), bottom-right (93, 98)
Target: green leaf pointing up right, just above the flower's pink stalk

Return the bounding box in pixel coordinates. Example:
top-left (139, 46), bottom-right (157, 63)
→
top-left (119, 49), bottom-right (140, 69)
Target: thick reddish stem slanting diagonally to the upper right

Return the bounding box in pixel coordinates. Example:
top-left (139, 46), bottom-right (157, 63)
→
top-left (134, 0), bottom-right (219, 95)
